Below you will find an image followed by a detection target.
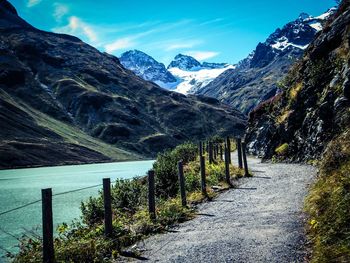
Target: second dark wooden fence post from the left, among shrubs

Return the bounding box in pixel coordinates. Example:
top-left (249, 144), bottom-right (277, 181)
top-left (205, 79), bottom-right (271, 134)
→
top-left (102, 178), bottom-right (113, 237)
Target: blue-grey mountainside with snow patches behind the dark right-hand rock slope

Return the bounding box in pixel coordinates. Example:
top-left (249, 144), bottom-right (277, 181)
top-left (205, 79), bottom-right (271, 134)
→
top-left (195, 8), bottom-right (335, 114)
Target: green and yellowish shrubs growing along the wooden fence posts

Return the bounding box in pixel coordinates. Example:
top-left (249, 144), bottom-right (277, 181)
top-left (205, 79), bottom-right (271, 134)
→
top-left (9, 143), bottom-right (243, 263)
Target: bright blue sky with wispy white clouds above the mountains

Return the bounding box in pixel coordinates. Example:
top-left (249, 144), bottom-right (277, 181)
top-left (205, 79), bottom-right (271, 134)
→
top-left (10, 0), bottom-right (335, 65)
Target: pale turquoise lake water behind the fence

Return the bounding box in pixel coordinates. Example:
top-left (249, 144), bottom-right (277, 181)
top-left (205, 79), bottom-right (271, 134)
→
top-left (0, 161), bottom-right (154, 262)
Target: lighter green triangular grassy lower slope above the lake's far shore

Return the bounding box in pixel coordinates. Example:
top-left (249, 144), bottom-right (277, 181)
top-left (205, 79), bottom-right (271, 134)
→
top-left (0, 90), bottom-right (141, 168)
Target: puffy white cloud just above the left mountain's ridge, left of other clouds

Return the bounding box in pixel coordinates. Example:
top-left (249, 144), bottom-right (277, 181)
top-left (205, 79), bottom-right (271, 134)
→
top-left (53, 16), bottom-right (98, 43)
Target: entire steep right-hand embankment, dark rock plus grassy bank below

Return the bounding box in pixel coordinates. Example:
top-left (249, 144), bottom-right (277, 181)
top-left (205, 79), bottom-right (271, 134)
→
top-left (246, 0), bottom-right (350, 262)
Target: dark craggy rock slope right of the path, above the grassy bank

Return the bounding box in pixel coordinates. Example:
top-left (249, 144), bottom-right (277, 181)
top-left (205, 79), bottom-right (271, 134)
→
top-left (246, 1), bottom-right (350, 161)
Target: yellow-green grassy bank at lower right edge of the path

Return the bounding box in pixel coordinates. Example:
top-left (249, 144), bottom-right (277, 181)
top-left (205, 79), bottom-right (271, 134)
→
top-left (305, 131), bottom-right (350, 262)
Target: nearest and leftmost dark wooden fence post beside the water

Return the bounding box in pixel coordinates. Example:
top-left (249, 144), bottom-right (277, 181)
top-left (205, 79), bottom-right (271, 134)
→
top-left (41, 188), bottom-right (55, 263)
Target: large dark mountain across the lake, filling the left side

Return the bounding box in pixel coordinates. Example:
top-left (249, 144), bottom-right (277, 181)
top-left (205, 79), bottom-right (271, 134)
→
top-left (0, 0), bottom-right (246, 168)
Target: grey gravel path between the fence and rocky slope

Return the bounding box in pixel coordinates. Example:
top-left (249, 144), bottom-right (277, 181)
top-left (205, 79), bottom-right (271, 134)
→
top-left (127, 154), bottom-right (316, 262)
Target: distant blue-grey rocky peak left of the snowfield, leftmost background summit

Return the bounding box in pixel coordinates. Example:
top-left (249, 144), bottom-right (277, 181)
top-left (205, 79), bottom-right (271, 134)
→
top-left (119, 50), bottom-right (177, 88)
